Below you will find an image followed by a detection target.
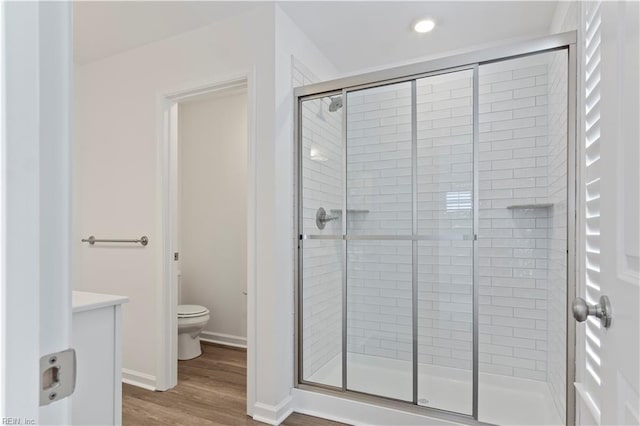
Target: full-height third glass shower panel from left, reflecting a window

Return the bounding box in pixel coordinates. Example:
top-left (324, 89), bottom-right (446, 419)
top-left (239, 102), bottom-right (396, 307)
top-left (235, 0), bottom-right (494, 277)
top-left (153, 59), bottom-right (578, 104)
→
top-left (416, 70), bottom-right (473, 414)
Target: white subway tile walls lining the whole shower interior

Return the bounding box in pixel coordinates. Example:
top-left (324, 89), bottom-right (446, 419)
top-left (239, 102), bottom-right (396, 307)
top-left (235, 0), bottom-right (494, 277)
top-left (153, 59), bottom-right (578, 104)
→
top-left (303, 52), bottom-right (567, 409)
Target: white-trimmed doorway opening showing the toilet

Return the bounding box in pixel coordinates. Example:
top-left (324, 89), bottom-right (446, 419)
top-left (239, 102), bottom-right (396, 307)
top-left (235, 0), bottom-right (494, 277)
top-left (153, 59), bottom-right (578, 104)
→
top-left (157, 73), bottom-right (255, 414)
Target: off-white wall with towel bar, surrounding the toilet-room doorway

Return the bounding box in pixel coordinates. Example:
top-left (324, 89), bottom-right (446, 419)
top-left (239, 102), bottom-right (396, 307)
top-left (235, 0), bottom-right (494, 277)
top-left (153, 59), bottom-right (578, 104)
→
top-left (73, 4), bottom-right (336, 422)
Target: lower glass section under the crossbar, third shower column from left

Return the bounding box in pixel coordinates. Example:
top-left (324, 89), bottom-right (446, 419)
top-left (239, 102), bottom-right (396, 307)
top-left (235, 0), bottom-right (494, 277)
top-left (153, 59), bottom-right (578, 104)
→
top-left (418, 241), bottom-right (473, 415)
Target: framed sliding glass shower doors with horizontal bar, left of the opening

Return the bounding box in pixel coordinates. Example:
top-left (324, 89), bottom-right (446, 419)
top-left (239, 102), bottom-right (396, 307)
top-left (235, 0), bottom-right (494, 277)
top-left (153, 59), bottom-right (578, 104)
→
top-left (300, 69), bottom-right (474, 414)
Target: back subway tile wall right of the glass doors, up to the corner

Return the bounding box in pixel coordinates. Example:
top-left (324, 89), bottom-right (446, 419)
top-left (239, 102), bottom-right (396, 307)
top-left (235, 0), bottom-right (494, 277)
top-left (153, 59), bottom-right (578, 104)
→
top-left (478, 54), bottom-right (552, 381)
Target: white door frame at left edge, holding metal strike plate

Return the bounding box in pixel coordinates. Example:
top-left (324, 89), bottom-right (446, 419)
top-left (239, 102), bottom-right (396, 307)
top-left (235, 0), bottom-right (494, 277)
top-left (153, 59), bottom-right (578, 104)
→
top-left (0, 1), bottom-right (71, 424)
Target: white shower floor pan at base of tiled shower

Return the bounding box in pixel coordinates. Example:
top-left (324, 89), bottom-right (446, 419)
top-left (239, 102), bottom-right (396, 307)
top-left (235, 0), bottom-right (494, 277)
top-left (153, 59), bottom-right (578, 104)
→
top-left (309, 353), bottom-right (564, 426)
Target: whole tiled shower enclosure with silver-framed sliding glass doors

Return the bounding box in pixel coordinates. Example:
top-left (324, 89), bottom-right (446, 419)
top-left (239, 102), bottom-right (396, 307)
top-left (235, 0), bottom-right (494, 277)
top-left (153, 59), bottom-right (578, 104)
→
top-left (296, 32), bottom-right (576, 425)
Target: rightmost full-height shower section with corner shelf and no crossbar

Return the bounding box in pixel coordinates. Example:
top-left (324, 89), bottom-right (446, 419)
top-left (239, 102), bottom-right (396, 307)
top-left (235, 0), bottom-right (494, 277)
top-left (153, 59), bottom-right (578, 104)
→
top-left (478, 50), bottom-right (568, 425)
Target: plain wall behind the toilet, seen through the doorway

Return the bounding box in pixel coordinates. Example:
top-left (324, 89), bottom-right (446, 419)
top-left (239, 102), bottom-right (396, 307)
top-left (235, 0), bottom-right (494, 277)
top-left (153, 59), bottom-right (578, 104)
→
top-left (178, 90), bottom-right (248, 345)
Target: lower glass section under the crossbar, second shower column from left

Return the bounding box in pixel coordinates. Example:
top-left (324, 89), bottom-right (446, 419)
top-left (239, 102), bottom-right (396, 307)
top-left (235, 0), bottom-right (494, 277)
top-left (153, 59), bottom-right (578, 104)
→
top-left (347, 240), bottom-right (413, 401)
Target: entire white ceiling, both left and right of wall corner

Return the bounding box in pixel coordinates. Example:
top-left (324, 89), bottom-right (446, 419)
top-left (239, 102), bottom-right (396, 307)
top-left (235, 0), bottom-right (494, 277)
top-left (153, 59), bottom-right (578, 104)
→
top-left (73, 1), bottom-right (557, 72)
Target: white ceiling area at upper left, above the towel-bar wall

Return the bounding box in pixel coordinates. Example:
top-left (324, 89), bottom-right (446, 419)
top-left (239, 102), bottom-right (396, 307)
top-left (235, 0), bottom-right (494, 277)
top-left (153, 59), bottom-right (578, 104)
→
top-left (73, 1), bottom-right (256, 64)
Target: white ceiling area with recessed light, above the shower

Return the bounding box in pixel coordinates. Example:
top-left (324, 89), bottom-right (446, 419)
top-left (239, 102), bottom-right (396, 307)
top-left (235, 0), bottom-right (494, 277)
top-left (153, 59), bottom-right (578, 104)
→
top-left (281, 1), bottom-right (557, 72)
